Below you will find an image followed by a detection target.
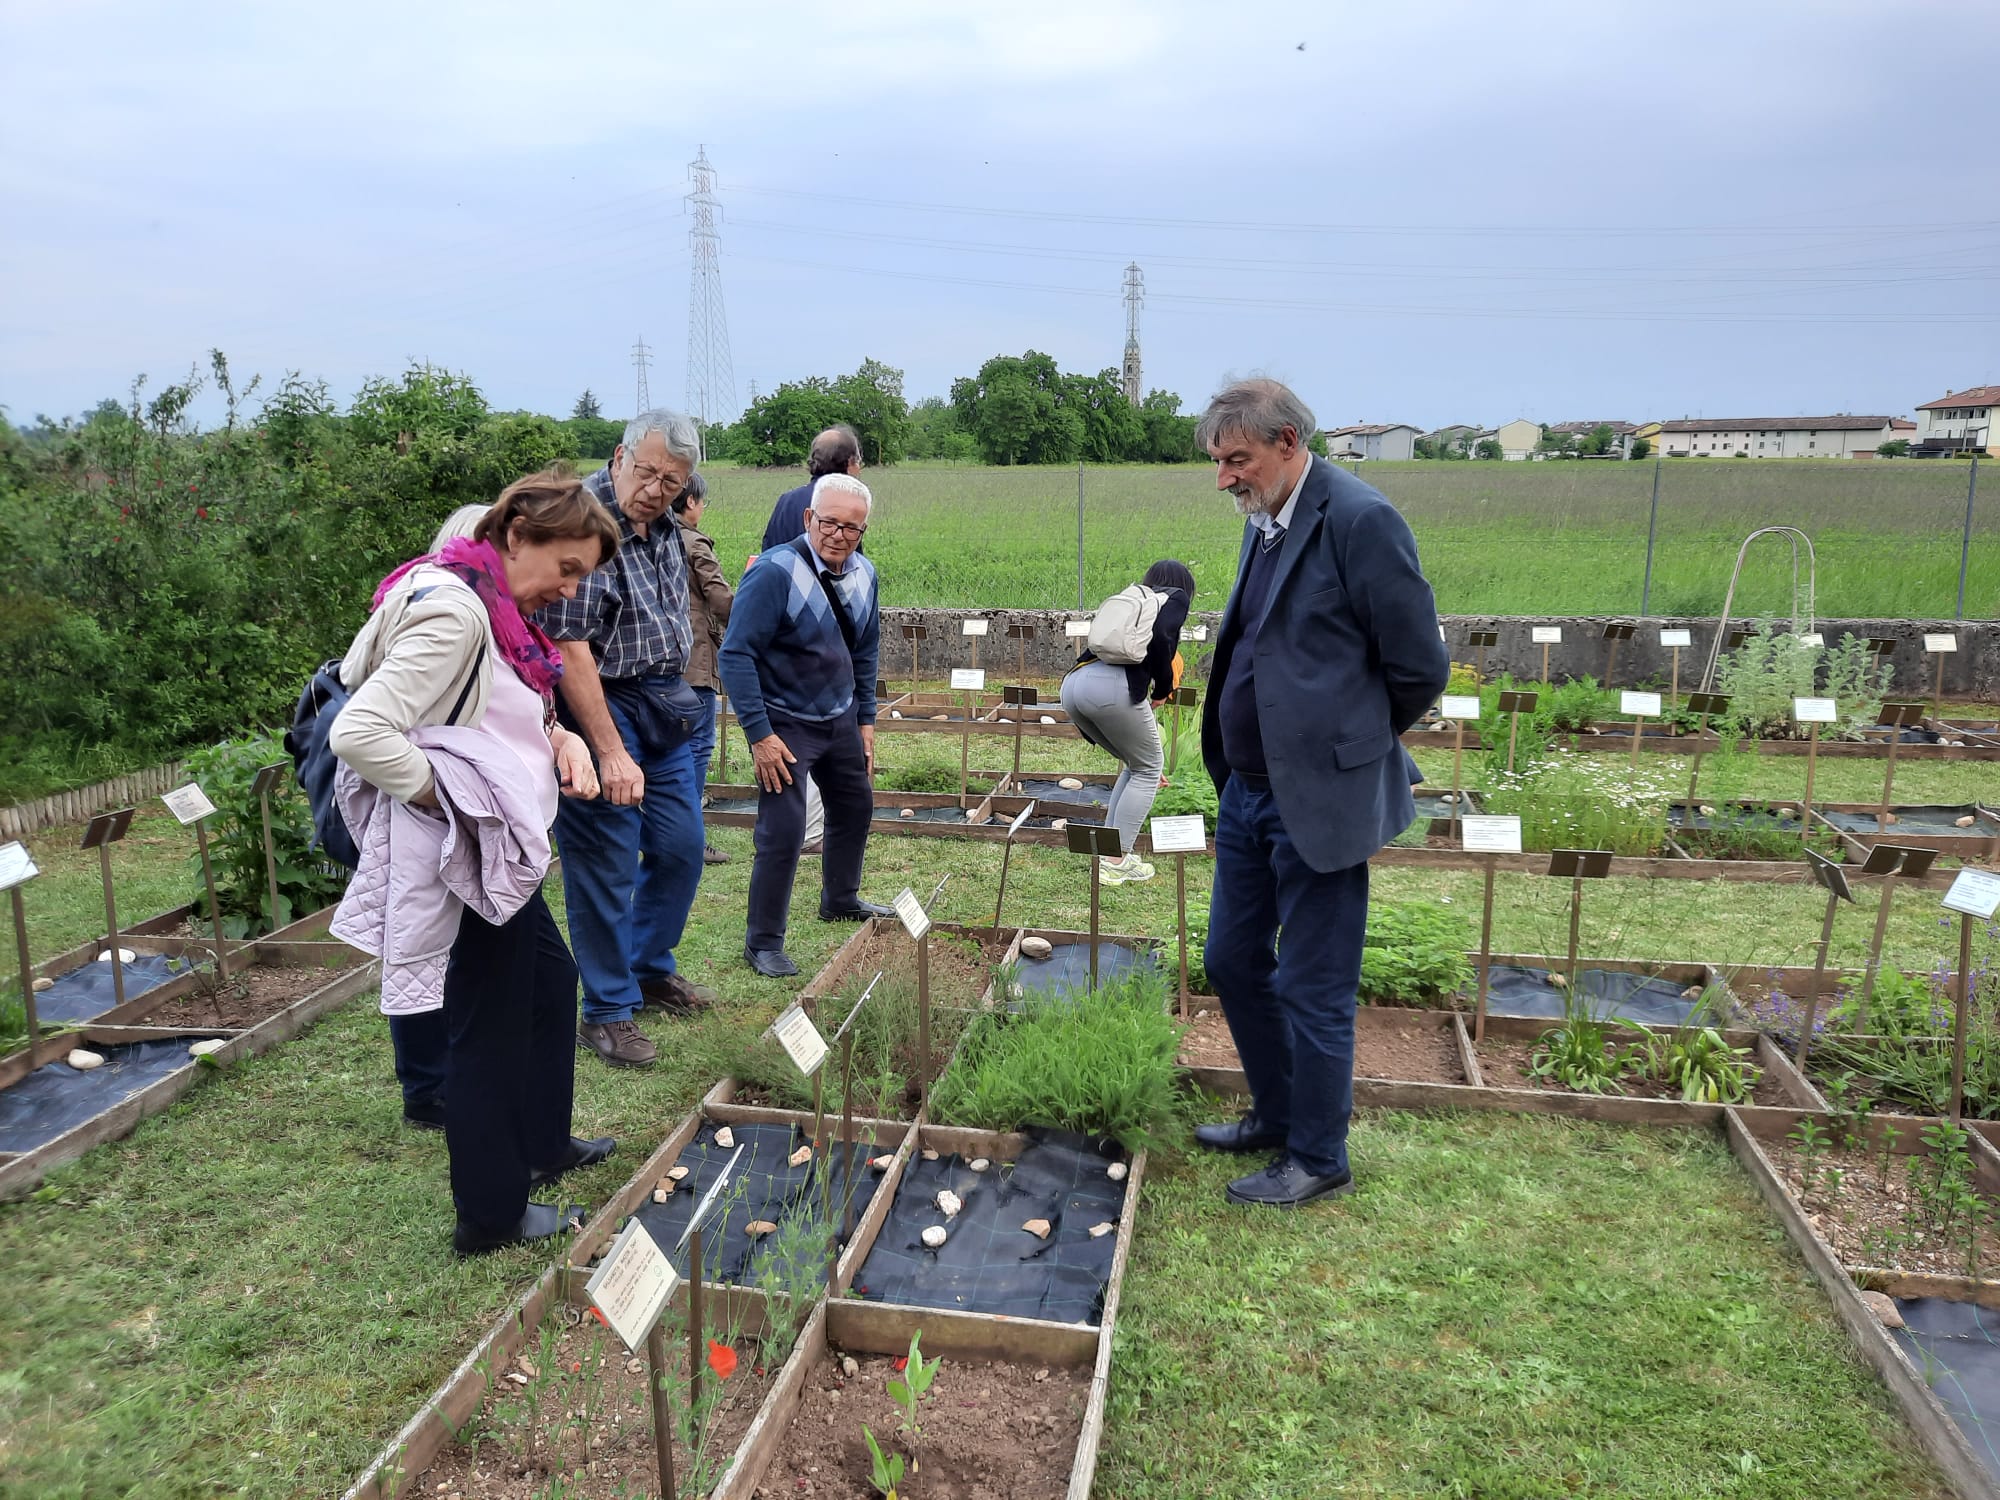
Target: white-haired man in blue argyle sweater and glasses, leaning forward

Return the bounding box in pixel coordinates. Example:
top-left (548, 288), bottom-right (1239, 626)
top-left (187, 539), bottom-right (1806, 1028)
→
top-left (716, 474), bottom-right (890, 978)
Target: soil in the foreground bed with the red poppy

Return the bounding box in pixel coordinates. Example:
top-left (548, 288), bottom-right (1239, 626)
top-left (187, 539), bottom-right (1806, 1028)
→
top-left (402, 1306), bottom-right (776, 1500)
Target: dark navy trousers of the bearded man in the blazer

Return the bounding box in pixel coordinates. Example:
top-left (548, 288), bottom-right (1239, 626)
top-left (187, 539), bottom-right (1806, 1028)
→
top-left (1204, 776), bottom-right (1368, 1176)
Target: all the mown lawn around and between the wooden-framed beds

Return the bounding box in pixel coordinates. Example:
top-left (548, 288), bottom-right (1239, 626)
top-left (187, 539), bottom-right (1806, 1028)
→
top-left (0, 736), bottom-right (1990, 1500)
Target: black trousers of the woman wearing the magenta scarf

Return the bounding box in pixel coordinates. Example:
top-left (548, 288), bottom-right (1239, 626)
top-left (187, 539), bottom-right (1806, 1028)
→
top-left (444, 892), bottom-right (576, 1232)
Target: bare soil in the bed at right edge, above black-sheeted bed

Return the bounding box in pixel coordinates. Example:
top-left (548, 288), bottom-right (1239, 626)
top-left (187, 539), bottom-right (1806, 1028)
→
top-left (1758, 1140), bottom-right (2000, 1278)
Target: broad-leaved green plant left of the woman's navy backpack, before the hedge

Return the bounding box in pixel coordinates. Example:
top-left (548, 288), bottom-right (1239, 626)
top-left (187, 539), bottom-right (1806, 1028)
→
top-left (188, 734), bottom-right (348, 938)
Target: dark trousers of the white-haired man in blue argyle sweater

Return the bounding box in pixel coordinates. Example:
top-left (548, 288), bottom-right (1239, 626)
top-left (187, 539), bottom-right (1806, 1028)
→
top-left (744, 706), bottom-right (874, 948)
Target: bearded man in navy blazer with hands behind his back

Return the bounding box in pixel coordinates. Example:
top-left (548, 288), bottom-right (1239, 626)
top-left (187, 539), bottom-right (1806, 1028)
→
top-left (1196, 380), bottom-right (1452, 1208)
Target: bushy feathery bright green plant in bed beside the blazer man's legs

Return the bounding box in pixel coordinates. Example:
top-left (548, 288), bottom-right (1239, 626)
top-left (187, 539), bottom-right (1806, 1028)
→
top-left (930, 964), bottom-right (1180, 1150)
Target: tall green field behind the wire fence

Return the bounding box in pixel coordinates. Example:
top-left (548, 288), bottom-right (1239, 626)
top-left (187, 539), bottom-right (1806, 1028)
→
top-left (704, 460), bottom-right (2000, 620)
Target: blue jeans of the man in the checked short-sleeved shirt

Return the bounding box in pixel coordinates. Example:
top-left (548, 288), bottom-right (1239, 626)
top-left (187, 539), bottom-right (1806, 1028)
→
top-left (556, 708), bottom-right (702, 1026)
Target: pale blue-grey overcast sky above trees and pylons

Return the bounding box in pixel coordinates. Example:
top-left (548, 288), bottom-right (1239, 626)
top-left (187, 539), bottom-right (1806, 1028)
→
top-left (0, 0), bottom-right (2000, 426)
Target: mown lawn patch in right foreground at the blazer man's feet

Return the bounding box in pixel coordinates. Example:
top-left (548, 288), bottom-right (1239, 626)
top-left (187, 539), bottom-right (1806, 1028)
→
top-left (1096, 1112), bottom-right (1950, 1500)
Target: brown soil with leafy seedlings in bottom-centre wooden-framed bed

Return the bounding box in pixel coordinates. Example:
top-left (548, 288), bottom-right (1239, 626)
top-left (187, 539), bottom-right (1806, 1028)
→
top-left (756, 1356), bottom-right (1090, 1500)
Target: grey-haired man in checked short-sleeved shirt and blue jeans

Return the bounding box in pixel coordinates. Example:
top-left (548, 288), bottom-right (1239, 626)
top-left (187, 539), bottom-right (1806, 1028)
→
top-left (536, 410), bottom-right (714, 1068)
